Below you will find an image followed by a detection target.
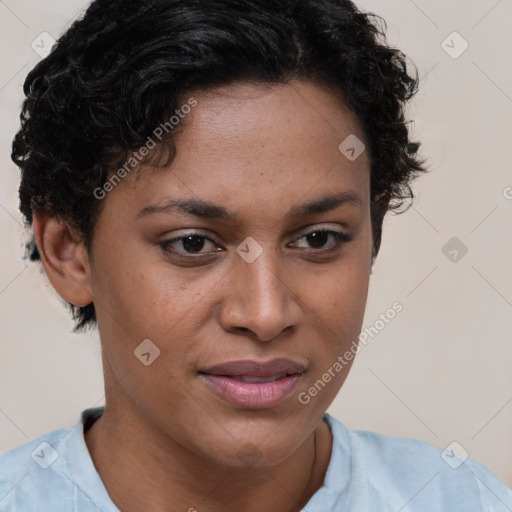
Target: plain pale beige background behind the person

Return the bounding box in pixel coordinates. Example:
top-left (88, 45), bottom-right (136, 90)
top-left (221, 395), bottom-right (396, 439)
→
top-left (0, 0), bottom-right (512, 486)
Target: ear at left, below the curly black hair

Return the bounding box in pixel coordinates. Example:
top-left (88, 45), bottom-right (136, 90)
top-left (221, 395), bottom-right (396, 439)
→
top-left (32, 212), bottom-right (93, 307)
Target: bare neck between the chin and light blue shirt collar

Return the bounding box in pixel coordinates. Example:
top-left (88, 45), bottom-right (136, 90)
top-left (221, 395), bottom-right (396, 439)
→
top-left (85, 404), bottom-right (331, 512)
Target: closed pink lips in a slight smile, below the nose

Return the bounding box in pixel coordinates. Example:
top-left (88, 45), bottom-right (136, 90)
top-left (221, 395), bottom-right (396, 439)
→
top-left (199, 359), bottom-right (305, 409)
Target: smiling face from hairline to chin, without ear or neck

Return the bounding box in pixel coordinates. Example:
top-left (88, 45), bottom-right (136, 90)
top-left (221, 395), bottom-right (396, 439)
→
top-left (90, 82), bottom-right (372, 466)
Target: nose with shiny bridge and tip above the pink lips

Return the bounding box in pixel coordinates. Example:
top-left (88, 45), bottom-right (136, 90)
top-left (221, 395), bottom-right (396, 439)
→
top-left (220, 251), bottom-right (303, 341)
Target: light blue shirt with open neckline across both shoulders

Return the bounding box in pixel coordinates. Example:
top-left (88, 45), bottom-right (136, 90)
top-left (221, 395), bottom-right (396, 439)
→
top-left (0, 407), bottom-right (512, 512)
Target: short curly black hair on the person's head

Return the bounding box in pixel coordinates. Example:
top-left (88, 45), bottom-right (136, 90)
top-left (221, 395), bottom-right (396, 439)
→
top-left (12, 0), bottom-right (426, 331)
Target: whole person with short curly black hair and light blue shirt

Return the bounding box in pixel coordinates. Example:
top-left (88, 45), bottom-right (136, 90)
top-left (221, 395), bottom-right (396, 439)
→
top-left (0, 0), bottom-right (512, 512)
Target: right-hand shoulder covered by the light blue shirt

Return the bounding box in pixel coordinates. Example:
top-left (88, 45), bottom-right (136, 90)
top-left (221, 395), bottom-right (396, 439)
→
top-left (328, 417), bottom-right (512, 512)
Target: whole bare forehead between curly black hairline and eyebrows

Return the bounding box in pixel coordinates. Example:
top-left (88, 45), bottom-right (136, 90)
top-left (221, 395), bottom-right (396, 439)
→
top-left (105, 82), bottom-right (369, 220)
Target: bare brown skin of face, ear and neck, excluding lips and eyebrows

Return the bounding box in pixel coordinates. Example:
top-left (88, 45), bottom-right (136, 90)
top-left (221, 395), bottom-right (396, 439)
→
top-left (34, 82), bottom-right (372, 512)
